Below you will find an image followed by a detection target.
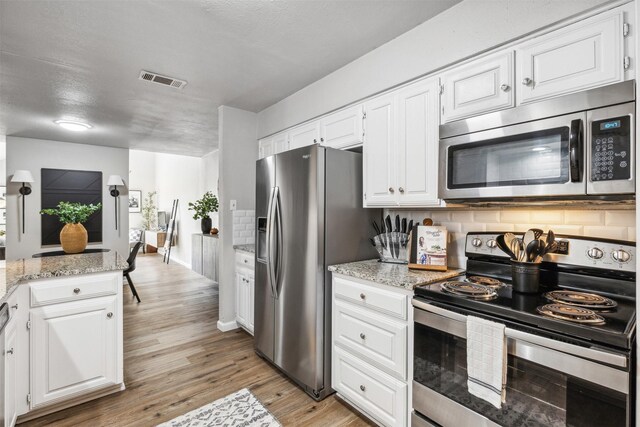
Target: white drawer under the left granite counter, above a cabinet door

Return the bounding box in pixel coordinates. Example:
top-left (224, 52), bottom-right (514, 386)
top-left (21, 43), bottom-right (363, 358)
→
top-left (30, 272), bottom-right (122, 307)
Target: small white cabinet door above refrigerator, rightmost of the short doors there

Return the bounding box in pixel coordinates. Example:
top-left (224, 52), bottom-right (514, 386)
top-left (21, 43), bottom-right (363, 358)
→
top-left (320, 105), bottom-right (364, 148)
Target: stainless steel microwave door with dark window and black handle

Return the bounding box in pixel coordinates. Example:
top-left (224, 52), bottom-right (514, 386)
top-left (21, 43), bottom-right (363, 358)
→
top-left (439, 112), bottom-right (586, 200)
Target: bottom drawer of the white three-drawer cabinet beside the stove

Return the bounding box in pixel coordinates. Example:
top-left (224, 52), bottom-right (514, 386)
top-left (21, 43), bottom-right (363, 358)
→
top-left (331, 347), bottom-right (408, 426)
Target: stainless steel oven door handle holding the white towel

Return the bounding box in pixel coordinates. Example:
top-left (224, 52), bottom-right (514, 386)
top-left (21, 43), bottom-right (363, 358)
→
top-left (412, 299), bottom-right (629, 369)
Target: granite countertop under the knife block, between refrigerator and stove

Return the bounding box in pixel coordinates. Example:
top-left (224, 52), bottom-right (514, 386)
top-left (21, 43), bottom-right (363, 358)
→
top-left (329, 259), bottom-right (464, 291)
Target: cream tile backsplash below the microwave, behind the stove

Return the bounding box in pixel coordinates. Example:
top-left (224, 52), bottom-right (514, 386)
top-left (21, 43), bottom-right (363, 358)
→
top-left (385, 208), bottom-right (636, 268)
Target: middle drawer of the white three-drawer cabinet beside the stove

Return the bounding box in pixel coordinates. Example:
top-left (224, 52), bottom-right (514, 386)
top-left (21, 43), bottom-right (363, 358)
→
top-left (333, 301), bottom-right (407, 380)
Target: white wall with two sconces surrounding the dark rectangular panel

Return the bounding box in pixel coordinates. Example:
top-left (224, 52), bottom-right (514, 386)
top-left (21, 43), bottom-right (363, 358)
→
top-left (7, 136), bottom-right (129, 260)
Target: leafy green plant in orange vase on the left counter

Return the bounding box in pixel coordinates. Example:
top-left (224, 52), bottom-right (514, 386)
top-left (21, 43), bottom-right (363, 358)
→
top-left (40, 202), bottom-right (102, 254)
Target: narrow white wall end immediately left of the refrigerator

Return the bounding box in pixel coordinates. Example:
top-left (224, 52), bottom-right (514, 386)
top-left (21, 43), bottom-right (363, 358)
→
top-left (218, 106), bottom-right (258, 330)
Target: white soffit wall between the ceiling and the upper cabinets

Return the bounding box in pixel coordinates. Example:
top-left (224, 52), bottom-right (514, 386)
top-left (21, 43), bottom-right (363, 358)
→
top-left (258, 0), bottom-right (610, 137)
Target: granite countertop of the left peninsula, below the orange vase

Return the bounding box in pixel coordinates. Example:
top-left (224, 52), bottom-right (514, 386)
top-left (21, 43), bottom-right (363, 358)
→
top-left (0, 251), bottom-right (129, 304)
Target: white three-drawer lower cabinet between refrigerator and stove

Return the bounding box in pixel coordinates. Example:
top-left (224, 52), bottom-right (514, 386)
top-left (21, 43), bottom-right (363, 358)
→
top-left (331, 273), bottom-right (413, 427)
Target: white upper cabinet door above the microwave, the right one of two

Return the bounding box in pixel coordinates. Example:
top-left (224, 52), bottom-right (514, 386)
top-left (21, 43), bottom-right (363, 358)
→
top-left (516, 12), bottom-right (624, 103)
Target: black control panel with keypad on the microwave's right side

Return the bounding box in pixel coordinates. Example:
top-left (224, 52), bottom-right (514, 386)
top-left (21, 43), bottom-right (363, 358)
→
top-left (591, 116), bottom-right (632, 181)
